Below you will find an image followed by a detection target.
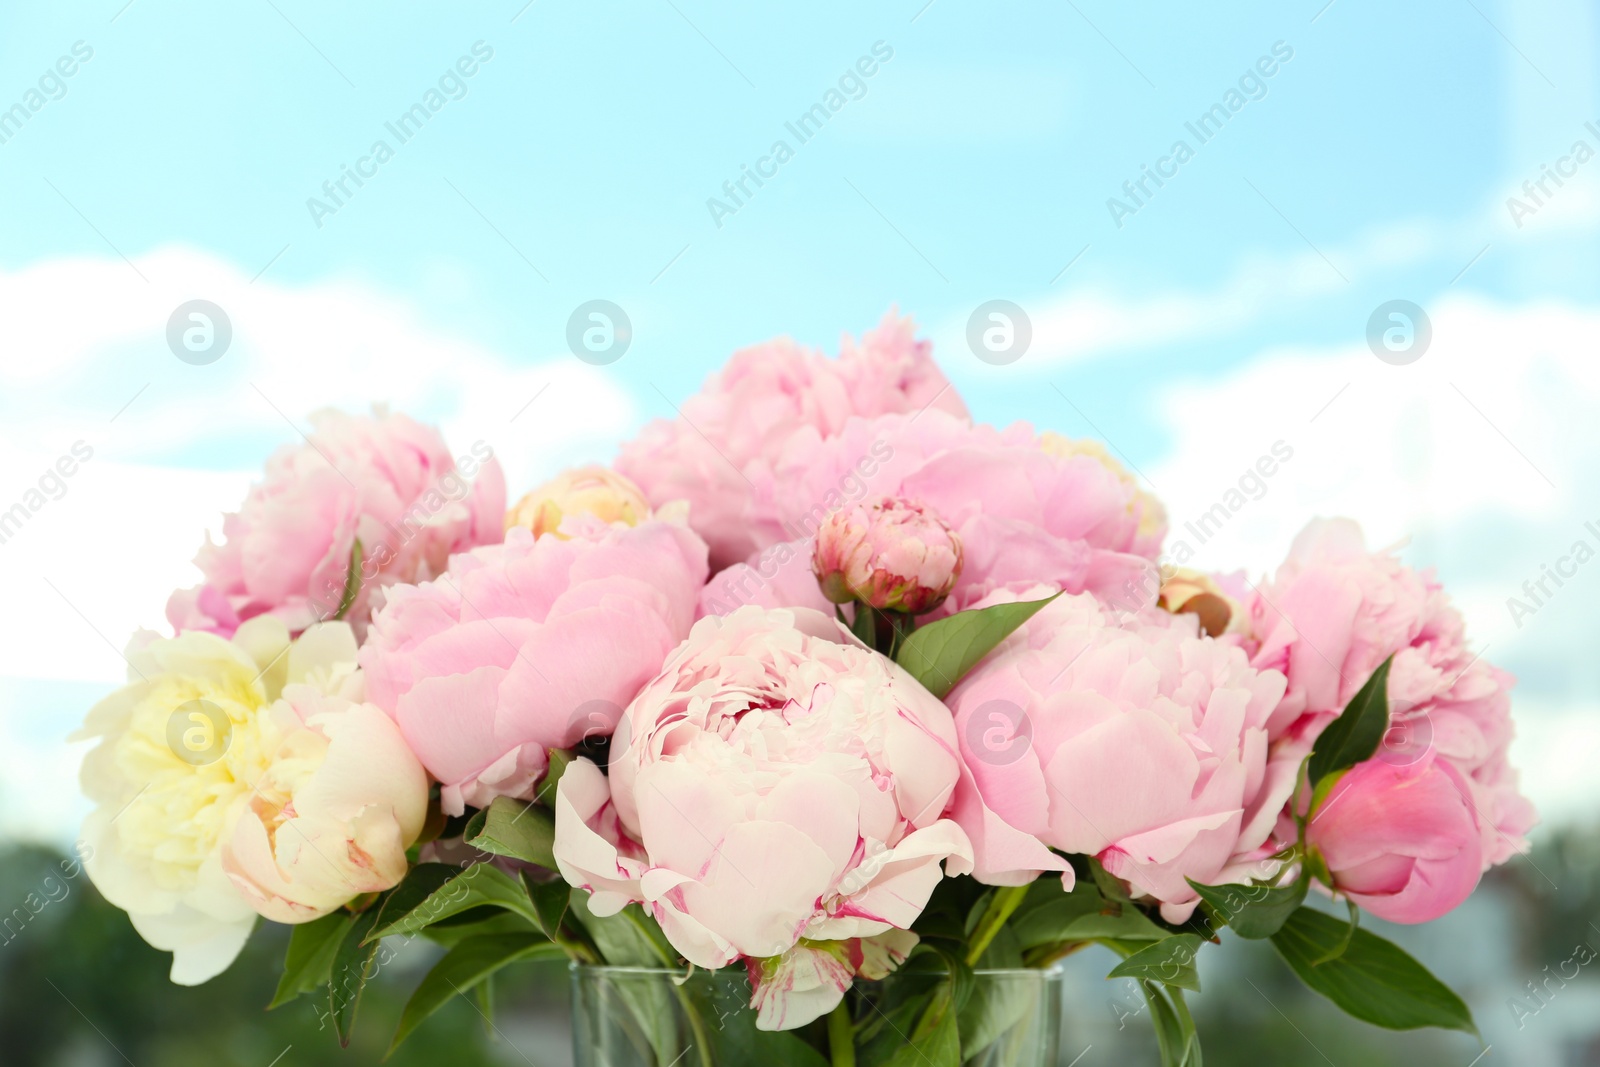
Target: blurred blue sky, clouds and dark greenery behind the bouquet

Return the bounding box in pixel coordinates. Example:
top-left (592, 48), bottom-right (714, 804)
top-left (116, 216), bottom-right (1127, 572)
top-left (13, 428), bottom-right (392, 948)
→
top-left (0, 0), bottom-right (1600, 1067)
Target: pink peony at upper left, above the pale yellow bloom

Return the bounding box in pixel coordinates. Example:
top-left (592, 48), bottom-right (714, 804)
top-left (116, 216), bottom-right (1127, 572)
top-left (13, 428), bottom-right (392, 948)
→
top-left (166, 411), bottom-right (506, 637)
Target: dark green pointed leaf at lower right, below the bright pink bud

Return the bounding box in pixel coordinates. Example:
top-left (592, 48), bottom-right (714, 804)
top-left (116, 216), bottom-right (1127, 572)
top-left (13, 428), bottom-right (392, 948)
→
top-left (1272, 907), bottom-right (1478, 1035)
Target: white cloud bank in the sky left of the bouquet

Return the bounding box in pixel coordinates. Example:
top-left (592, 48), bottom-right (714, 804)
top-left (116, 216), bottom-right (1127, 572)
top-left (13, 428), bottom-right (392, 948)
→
top-left (0, 250), bottom-right (634, 681)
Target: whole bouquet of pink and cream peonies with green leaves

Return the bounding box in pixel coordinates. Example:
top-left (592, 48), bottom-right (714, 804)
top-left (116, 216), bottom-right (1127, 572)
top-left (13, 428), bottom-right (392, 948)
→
top-left (80, 315), bottom-right (1534, 1067)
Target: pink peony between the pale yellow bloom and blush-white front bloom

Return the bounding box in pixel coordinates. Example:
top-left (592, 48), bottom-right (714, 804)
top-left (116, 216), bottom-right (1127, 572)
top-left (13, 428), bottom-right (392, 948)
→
top-left (360, 515), bottom-right (706, 814)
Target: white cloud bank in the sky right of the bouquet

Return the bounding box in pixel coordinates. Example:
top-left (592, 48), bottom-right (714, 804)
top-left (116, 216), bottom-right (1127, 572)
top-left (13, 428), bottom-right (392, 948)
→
top-left (1147, 298), bottom-right (1600, 822)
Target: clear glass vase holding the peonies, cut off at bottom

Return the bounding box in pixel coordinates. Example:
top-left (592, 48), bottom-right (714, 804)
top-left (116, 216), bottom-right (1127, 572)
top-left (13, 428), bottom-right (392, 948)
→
top-left (573, 965), bottom-right (1064, 1067)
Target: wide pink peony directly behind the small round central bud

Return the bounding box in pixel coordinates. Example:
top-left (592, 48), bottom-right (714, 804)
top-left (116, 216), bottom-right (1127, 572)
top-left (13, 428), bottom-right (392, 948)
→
top-left (702, 411), bottom-right (1166, 614)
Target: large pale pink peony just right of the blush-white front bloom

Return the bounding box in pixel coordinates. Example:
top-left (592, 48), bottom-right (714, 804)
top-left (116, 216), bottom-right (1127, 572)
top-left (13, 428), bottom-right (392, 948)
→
top-left (947, 595), bottom-right (1298, 921)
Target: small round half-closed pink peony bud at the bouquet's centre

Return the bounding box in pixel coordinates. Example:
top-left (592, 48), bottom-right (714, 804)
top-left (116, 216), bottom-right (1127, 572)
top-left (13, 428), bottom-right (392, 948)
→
top-left (811, 496), bottom-right (962, 614)
